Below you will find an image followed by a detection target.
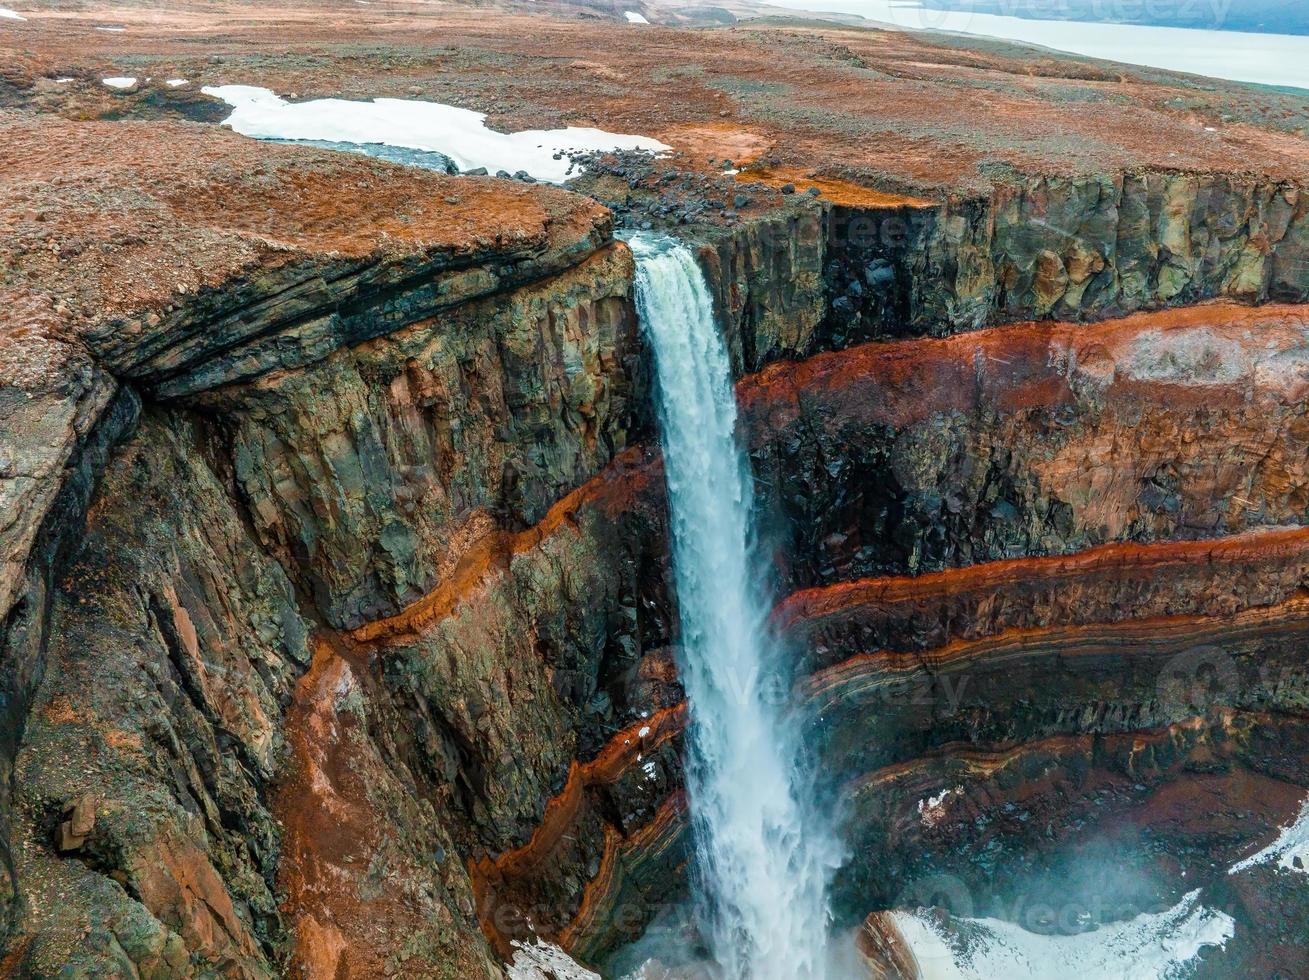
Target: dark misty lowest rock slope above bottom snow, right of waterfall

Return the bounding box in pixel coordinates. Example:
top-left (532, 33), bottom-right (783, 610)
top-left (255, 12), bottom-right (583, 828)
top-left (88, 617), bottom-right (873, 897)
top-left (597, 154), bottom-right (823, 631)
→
top-left (842, 708), bottom-right (1306, 925)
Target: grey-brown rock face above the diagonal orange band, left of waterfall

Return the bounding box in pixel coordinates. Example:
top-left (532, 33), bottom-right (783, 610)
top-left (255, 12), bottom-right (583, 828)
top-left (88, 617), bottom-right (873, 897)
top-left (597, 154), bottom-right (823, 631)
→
top-left (202, 245), bottom-right (649, 628)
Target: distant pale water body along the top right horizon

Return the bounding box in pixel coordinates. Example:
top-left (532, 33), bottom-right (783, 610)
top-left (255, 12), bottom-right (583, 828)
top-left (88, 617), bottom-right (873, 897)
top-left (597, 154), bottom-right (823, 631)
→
top-left (770, 0), bottom-right (1309, 90)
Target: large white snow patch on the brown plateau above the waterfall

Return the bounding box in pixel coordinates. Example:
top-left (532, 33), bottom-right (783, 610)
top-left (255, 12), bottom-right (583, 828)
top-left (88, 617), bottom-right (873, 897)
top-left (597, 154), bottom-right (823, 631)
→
top-left (200, 85), bottom-right (669, 183)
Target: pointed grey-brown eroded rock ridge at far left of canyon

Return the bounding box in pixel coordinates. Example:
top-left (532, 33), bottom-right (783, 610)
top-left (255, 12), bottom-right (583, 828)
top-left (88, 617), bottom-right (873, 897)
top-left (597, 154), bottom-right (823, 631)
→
top-left (13, 415), bottom-right (309, 976)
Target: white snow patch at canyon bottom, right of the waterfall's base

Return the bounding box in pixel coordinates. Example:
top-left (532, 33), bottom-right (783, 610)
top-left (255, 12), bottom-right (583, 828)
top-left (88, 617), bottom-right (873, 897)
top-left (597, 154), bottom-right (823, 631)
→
top-left (891, 888), bottom-right (1236, 980)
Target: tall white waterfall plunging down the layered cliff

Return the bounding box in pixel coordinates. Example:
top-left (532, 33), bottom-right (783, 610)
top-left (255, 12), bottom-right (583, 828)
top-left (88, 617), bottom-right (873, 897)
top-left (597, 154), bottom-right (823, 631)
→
top-left (630, 236), bottom-right (839, 980)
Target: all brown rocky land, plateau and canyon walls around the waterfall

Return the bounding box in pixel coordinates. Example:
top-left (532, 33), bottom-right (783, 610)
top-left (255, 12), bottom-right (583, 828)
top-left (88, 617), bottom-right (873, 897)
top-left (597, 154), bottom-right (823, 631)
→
top-left (0, 4), bottom-right (1309, 979)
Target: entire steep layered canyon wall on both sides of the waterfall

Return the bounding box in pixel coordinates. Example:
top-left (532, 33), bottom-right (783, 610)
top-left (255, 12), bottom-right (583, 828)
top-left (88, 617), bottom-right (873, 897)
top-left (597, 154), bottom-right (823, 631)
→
top-left (0, 155), bottom-right (1309, 977)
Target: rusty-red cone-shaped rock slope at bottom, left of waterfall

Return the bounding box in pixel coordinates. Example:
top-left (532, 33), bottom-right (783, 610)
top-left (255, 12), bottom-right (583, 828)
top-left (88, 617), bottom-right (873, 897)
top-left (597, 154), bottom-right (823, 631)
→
top-left (272, 637), bottom-right (501, 980)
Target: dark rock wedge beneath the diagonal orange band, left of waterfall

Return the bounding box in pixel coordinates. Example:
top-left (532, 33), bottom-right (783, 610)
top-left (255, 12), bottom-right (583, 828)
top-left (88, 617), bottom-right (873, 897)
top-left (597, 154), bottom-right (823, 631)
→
top-left (366, 454), bottom-right (669, 850)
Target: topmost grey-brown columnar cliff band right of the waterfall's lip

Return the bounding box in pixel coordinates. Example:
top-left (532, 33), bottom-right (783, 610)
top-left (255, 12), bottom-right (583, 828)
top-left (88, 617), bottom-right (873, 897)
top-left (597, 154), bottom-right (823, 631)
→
top-left (685, 170), bottom-right (1309, 373)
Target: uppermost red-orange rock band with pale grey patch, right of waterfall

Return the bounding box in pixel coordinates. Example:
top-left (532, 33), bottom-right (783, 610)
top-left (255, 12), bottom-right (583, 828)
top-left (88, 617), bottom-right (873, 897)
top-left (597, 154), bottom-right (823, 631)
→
top-left (737, 304), bottom-right (1309, 436)
